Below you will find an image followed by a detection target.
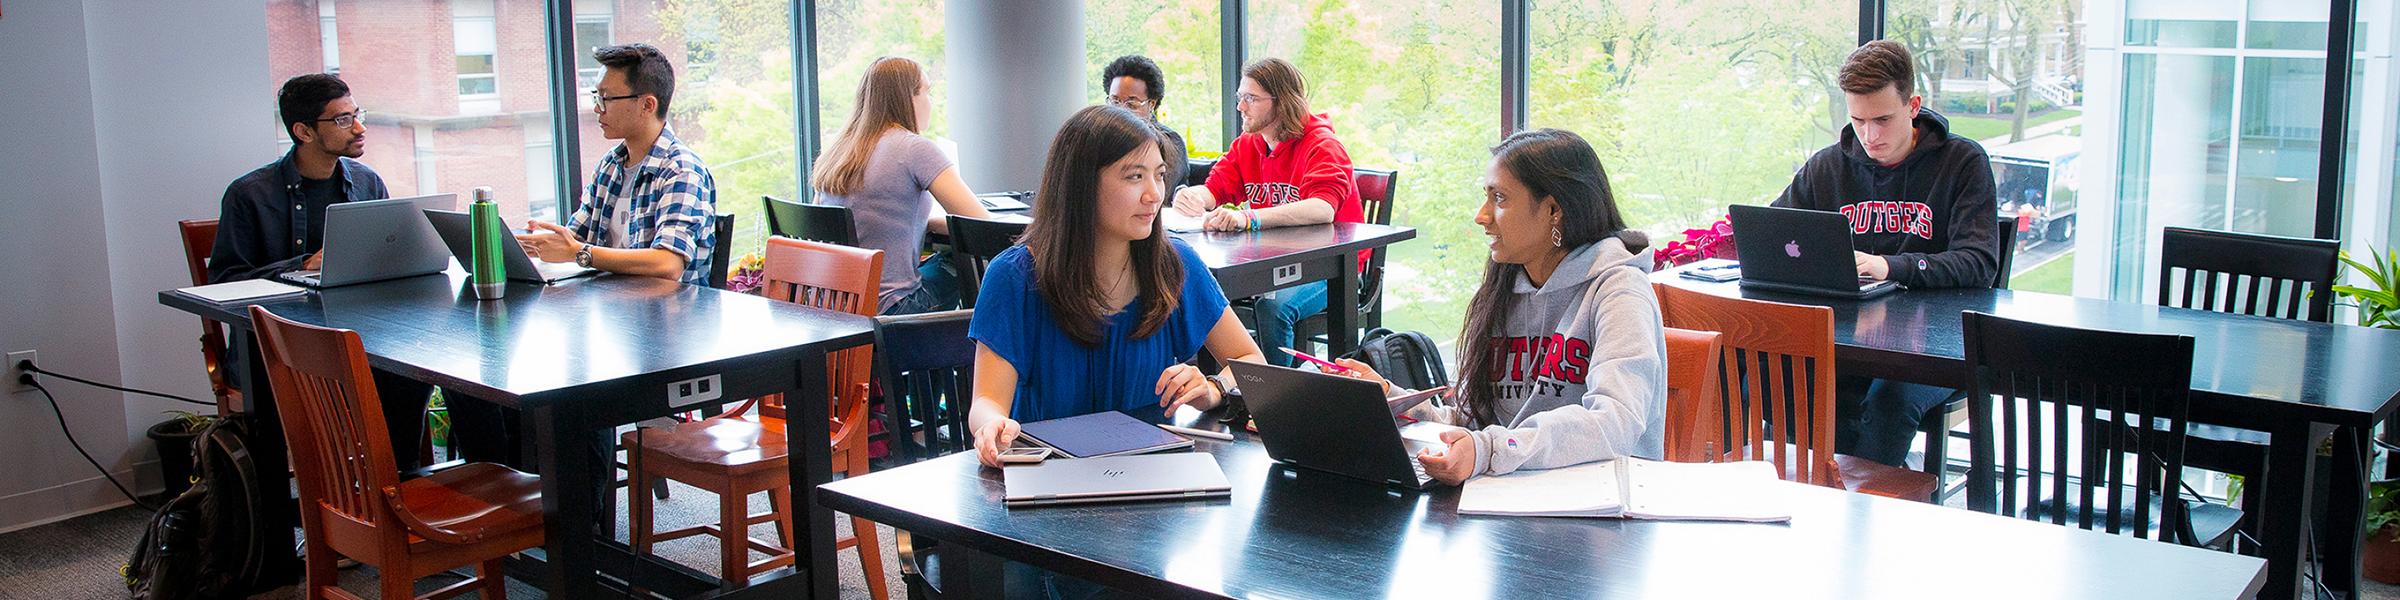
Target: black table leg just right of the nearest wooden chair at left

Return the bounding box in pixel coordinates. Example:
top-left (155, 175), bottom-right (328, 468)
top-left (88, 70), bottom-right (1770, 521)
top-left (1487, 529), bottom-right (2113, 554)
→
top-left (526, 406), bottom-right (602, 598)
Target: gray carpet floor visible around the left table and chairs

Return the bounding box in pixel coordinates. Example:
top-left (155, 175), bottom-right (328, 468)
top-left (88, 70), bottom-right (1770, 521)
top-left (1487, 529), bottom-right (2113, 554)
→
top-left (0, 482), bottom-right (907, 600)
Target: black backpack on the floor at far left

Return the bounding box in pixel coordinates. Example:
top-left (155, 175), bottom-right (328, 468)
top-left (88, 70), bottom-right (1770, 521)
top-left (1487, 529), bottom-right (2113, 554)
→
top-left (125, 418), bottom-right (266, 600)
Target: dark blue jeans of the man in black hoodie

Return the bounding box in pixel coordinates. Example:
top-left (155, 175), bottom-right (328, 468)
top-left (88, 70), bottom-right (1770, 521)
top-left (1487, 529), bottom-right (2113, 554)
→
top-left (1834, 377), bottom-right (1958, 468)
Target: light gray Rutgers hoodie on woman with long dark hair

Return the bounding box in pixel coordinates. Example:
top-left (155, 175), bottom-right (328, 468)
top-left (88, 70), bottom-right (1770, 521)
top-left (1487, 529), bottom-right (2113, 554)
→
top-left (1411, 238), bottom-right (1666, 475)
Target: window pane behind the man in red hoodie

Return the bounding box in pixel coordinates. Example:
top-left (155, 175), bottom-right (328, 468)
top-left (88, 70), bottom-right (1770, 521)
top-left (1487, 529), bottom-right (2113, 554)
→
top-left (1246, 0), bottom-right (1500, 338)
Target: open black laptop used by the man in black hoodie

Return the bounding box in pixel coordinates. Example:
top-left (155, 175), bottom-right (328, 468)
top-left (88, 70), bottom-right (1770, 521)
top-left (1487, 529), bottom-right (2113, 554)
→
top-left (1726, 206), bottom-right (1901, 298)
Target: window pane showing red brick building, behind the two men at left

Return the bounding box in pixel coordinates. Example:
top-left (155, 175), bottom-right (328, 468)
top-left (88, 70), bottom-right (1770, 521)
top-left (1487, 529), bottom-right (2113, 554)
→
top-left (259, 0), bottom-right (557, 223)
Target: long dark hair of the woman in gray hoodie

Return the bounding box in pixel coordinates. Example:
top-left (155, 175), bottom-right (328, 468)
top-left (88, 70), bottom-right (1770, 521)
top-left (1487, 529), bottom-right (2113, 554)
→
top-left (1459, 130), bottom-right (1649, 425)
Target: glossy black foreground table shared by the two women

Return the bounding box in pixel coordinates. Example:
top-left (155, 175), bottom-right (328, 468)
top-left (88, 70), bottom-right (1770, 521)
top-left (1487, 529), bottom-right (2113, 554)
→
top-left (816, 434), bottom-right (2266, 600)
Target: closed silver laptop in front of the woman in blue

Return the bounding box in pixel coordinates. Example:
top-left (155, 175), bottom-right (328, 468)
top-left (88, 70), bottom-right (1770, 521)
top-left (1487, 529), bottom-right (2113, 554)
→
top-left (1001, 451), bottom-right (1234, 506)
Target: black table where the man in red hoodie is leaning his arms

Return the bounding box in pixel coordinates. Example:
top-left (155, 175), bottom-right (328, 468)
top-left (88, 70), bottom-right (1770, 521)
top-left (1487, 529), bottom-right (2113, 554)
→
top-left (950, 211), bottom-right (1416, 355)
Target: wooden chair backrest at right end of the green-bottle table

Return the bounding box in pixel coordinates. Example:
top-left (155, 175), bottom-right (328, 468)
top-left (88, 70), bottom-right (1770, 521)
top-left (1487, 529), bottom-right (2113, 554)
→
top-left (758, 238), bottom-right (883, 418)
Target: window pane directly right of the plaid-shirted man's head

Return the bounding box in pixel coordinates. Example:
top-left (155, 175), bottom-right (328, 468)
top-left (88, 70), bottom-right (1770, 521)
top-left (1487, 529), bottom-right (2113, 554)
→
top-left (576, 0), bottom-right (799, 257)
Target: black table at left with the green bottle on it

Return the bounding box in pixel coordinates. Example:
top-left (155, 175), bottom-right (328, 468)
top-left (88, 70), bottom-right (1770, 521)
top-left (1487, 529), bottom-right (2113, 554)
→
top-left (158, 269), bottom-right (874, 598)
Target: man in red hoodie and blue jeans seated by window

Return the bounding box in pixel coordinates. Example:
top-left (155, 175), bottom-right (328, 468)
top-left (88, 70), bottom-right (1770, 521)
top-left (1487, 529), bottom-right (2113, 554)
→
top-left (1176, 58), bottom-right (1368, 367)
